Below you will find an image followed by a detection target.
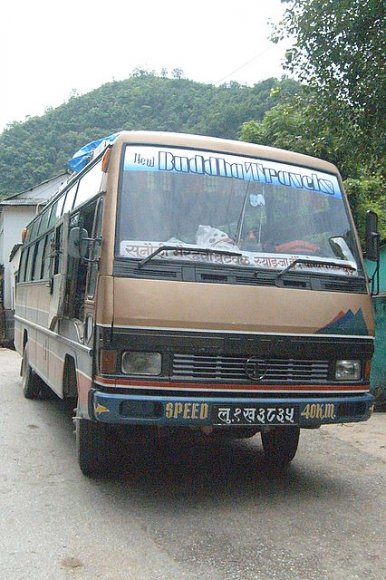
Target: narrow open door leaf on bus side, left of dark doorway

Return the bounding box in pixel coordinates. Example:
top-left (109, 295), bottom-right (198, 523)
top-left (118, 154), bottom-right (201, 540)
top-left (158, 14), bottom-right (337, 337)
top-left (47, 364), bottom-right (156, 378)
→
top-left (48, 213), bottom-right (69, 330)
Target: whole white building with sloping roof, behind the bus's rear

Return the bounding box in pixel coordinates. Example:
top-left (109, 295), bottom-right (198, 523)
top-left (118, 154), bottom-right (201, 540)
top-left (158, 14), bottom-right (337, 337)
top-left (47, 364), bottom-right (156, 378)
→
top-left (0, 172), bottom-right (69, 343)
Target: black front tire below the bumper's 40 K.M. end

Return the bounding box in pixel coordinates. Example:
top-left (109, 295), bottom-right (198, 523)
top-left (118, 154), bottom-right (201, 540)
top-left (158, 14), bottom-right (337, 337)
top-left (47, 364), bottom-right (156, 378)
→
top-left (261, 426), bottom-right (300, 469)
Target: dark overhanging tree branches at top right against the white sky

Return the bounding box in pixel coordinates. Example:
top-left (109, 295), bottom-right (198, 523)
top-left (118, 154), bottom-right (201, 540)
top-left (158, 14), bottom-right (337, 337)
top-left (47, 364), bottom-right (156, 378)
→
top-left (274, 0), bottom-right (386, 169)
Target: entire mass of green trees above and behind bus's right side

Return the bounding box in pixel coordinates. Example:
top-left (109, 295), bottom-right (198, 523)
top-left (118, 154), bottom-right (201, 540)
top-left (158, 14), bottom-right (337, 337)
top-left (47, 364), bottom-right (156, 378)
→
top-left (241, 0), bottom-right (386, 241)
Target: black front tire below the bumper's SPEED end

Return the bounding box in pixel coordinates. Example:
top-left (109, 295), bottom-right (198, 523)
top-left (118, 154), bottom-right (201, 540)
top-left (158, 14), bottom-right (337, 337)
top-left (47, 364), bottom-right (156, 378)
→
top-left (76, 419), bottom-right (115, 476)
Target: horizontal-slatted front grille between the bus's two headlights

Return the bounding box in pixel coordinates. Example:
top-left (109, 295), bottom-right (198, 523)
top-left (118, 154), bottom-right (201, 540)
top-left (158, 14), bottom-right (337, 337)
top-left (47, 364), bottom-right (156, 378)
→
top-left (173, 354), bottom-right (329, 384)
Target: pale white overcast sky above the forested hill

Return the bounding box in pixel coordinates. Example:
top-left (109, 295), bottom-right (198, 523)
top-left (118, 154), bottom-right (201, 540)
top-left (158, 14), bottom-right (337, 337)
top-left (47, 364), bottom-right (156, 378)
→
top-left (0, 0), bottom-right (288, 131)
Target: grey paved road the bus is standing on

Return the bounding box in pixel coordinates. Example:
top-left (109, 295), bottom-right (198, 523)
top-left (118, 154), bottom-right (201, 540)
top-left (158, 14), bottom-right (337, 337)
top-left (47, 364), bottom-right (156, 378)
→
top-left (0, 350), bottom-right (386, 580)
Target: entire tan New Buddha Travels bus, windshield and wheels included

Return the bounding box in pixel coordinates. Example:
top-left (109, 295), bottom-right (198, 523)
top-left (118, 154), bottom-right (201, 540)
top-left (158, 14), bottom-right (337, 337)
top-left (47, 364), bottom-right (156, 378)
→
top-left (15, 131), bottom-right (378, 475)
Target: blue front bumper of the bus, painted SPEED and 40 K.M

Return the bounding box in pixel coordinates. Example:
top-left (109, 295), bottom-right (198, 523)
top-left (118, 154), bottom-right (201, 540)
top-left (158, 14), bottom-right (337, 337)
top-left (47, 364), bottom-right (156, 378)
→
top-left (88, 389), bottom-right (374, 427)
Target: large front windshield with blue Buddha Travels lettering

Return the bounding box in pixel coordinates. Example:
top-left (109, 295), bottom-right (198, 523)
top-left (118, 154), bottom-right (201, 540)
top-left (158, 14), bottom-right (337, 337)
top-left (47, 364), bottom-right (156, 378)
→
top-left (117, 145), bottom-right (357, 273)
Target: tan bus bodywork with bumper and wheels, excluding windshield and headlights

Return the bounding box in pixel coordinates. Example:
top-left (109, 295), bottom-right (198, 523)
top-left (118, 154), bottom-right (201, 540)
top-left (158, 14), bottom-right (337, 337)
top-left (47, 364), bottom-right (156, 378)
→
top-left (15, 132), bottom-right (374, 473)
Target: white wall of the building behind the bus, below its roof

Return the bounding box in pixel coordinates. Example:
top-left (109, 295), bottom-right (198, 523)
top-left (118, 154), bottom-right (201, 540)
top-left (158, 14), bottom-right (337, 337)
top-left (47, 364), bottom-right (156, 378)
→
top-left (0, 206), bottom-right (36, 310)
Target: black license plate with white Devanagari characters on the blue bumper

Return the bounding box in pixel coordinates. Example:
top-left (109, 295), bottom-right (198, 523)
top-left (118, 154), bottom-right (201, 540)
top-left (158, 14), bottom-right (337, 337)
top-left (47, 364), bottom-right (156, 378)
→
top-left (212, 405), bottom-right (299, 425)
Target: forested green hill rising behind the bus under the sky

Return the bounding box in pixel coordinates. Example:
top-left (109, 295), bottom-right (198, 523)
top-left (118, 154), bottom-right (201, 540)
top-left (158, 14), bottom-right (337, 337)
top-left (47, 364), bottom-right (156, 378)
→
top-left (0, 71), bottom-right (296, 199)
